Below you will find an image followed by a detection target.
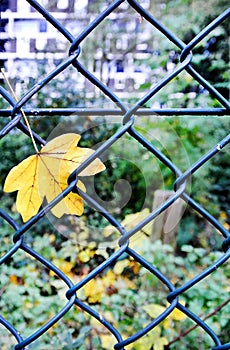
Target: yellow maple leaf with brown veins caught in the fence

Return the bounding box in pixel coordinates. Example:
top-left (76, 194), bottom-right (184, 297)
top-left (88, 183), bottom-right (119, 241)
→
top-left (3, 133), bottom-right (105, 222)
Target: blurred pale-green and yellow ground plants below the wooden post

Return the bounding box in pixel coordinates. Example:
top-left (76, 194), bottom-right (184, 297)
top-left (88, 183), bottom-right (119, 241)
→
top-left (0, 212), bottom-right (230, 350)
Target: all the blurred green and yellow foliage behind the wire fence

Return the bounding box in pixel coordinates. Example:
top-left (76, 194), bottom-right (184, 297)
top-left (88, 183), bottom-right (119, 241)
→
top-left (0, 0), bottom-right (230, 350)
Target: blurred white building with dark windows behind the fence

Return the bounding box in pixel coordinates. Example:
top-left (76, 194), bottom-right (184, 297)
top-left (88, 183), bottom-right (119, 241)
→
top-left (0, 0), bottom-right (153, 97)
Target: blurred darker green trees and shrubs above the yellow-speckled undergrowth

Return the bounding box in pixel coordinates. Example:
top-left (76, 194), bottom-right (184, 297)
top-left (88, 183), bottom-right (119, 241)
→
top-left (0, 0), bottom-right (229, 227)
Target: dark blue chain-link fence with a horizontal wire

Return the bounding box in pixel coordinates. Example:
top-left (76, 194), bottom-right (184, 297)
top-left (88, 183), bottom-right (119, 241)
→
top-left (0, 0), bottom-right (230, 350)
